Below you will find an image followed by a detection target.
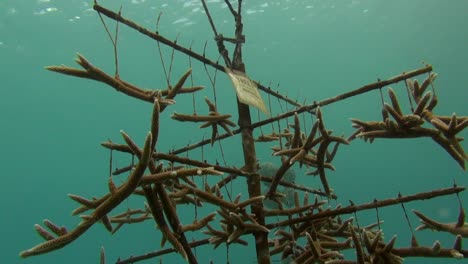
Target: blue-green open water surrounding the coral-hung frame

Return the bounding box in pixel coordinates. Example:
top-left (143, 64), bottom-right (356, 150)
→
top-left (0, 0), bottom-right (468, 264)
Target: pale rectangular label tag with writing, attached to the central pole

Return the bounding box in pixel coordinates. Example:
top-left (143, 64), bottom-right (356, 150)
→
top-left (225, 68), bottom-right (269, 115)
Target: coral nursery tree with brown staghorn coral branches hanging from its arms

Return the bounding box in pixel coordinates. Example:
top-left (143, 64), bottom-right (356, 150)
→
top-left (20, 0), bottom-right (468, 264)
